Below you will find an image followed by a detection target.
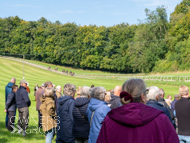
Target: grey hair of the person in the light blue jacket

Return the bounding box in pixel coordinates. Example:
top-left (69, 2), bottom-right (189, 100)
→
top-left (90, 87), bottom-right (106, 101)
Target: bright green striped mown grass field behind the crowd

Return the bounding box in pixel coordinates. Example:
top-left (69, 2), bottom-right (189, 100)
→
top-left (0, 57), bottom-right (187, 143)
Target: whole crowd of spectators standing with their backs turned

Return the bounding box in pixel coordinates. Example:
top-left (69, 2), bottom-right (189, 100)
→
top-left (5, 78), bottom-right (190, 143)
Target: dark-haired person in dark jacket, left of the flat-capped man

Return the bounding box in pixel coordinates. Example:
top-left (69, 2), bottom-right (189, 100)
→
top-left (5, 85), bottom-right (18, 131)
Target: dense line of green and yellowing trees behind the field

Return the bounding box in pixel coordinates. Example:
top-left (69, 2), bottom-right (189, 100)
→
top-left (0, 0), bottom-right (190, 73)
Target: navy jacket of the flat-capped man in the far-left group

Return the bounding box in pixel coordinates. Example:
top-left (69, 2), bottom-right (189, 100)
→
top-left (16, 86), bottom-right (31, 108)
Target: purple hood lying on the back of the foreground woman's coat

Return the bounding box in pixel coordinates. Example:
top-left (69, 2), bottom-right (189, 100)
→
top-left (108, 103), bottom-right (163, 127)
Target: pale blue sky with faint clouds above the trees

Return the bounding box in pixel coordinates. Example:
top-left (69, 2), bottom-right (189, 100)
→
top-left (0, 0), bottom-right (182, 26)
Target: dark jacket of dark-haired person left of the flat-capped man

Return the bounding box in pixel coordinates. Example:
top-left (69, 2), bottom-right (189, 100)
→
top-left (5, 91), bottom-right (16, 112)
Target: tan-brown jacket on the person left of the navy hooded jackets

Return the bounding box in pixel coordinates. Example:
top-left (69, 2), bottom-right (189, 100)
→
top-left (40, 90), bottom-right (57, 131)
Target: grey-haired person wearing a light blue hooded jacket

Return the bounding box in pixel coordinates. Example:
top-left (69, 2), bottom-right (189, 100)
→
top-left (86, 87), bottom-right (111, 143)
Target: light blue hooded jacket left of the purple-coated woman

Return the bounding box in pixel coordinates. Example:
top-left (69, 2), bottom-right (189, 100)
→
top-left (86, 98), bottom-right (111, 143)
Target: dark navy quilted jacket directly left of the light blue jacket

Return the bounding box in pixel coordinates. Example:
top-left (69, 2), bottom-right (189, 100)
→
top-left (73, 97), bottom-right (90, 138)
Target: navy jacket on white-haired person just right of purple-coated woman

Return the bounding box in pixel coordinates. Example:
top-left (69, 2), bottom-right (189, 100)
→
top-left (146, 100), bottom-right (172, 122)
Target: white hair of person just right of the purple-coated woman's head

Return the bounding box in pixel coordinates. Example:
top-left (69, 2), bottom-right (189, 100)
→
top-left (147, 86), bottom-right (160, 100)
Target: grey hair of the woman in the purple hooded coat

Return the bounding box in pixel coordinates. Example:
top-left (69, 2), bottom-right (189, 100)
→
top-left (122, 79), bottom-right (146, 102)
